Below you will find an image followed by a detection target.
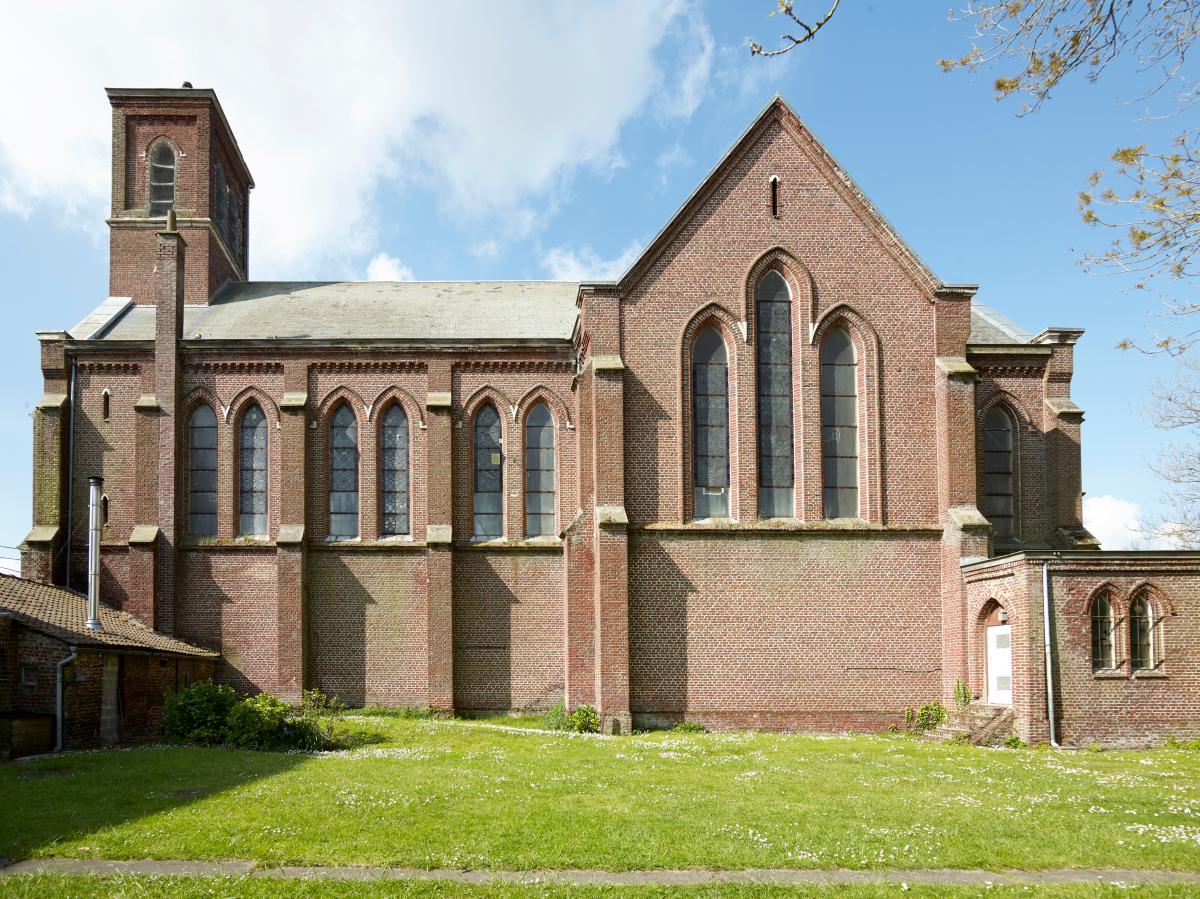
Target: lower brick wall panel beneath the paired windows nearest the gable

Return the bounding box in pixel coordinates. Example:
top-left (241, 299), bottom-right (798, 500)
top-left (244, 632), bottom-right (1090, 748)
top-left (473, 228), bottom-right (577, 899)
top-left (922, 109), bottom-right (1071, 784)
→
top-left (454, 549), bottom-right (564, 709)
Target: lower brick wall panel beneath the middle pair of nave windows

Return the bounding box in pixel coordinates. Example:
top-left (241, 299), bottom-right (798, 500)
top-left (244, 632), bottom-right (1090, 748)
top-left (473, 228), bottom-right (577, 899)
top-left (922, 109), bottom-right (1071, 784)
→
top-left (307, 549), bottom-right (428, 707)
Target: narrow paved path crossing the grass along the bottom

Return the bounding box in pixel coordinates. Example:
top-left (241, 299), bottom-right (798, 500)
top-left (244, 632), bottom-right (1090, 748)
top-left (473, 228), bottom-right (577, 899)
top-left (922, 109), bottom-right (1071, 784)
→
top-left (0, 858), bottom-right (1200, 886)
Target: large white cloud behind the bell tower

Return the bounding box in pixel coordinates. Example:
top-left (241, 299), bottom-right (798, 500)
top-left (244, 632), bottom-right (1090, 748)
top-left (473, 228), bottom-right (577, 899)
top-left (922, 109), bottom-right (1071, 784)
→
top-left (0, 0), bottom-right (713, 277)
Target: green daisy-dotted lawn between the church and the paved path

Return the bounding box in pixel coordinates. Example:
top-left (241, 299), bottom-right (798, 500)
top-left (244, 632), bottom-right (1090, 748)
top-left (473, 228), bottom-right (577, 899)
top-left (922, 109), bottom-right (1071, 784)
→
top-left (0, 717), bottom-right (1200, 873)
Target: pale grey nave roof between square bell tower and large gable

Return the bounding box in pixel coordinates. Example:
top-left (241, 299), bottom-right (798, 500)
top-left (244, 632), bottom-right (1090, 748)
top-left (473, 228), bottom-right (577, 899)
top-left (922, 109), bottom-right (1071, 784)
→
top-left (71, 281), bottom-right (580, 342)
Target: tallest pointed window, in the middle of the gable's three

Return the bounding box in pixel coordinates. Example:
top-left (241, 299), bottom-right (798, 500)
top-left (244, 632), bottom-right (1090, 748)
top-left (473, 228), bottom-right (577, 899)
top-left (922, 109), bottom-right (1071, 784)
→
top-left (755, 271), bottom-right (796, 519)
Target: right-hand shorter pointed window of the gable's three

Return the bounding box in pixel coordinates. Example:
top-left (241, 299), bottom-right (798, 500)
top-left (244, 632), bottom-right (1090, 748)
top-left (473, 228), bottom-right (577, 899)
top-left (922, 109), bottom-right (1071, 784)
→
top-left (821, 328), bottom-right (859, 519)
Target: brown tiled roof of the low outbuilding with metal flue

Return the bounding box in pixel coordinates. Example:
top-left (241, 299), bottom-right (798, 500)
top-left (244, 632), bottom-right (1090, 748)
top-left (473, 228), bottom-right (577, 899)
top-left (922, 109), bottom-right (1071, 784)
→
top-left (0, 575), bottom-right (217, 659)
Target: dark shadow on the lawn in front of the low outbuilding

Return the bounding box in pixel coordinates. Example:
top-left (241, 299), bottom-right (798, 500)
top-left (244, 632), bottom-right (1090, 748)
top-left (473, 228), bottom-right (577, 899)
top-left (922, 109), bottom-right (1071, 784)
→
top-left (0, 735), bottom-right (307, 861)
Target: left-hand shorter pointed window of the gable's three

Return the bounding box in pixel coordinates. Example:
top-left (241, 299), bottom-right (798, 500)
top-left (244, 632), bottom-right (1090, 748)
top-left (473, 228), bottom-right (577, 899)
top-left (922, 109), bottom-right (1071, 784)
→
top-left (691, 328), bottom-right (730, 519)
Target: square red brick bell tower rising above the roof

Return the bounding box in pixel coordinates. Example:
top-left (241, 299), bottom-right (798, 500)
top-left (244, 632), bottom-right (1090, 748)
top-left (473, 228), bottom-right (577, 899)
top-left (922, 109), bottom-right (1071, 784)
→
top-left (107, 82), bottom-right (254, 305)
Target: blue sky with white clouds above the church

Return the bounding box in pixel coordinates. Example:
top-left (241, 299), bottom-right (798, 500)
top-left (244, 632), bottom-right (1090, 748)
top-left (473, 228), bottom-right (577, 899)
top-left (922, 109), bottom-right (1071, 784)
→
top-left (0, 0), bottom-right (1174, 564)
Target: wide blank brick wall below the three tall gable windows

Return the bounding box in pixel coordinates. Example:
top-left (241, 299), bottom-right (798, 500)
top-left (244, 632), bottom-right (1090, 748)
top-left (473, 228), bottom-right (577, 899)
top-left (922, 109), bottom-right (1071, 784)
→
top-left (629, 531), bottom-right (941, 727)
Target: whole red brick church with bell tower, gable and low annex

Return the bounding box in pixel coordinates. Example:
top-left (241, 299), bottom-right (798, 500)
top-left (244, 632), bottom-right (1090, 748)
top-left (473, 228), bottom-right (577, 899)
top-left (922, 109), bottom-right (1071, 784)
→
top-left (23, 85), bottom-right (1200, 745)
